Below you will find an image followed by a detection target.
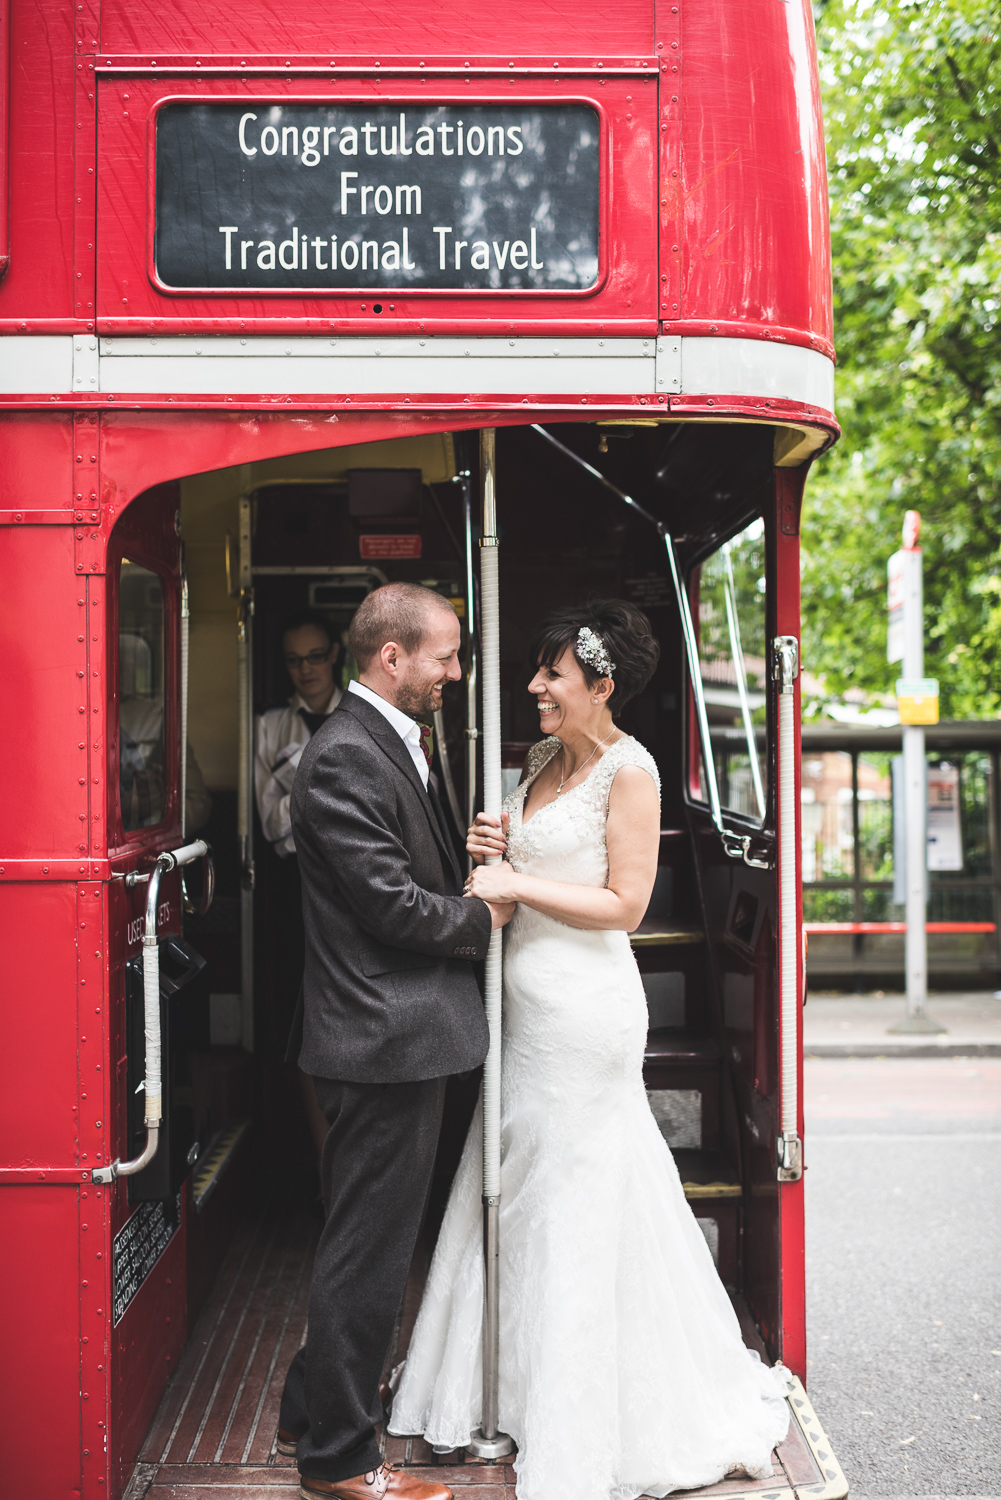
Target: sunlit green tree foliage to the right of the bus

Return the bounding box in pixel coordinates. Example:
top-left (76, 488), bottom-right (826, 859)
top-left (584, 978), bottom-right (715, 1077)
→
top-left (803, 0), bottom-right (1001, 719)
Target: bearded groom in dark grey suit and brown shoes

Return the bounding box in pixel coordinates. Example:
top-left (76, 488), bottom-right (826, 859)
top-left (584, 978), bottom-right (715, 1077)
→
top-left (278, 584), bottom-right (513, 1500)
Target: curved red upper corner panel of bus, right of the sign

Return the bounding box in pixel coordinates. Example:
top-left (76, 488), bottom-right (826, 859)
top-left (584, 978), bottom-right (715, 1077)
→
top-left (678, 0), bottom-right (833, 350)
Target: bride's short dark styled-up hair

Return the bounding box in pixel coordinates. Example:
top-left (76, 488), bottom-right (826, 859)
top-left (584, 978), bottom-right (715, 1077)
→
top-left (530, 599), bottom-right (660, 716)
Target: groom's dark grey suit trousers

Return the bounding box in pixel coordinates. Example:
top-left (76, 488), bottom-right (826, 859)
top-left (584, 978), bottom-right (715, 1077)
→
top-left (279, 1079), bottom-right (447, 1481)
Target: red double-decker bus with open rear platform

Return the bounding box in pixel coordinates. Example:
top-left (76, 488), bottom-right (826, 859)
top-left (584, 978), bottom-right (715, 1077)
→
top-left (0, 0), bottom-right (845, 1500)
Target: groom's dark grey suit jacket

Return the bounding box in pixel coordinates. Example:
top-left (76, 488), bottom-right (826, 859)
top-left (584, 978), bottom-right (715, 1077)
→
top-left (291, 693), bottom-right (491, 1083)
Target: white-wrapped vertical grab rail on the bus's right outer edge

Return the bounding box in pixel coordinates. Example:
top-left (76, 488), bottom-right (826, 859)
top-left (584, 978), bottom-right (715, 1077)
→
top-left (773, 636), bottom-right (803, 1182)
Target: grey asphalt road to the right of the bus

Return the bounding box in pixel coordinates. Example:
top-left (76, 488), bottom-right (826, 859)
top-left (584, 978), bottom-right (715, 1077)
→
top-left (806, 1058), bottom-right (1001, 1497)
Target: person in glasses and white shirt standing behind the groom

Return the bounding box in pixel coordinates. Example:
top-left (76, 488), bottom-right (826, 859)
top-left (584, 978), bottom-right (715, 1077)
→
top-left (254, 612), bottom-right (341, 1154)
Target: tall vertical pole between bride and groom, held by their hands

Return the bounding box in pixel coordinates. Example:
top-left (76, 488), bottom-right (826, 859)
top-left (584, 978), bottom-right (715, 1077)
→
top-left (468, 428), bottom-right (515, 1458)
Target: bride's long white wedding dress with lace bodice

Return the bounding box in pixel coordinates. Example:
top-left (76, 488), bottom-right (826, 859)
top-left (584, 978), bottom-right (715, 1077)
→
top-left (389, 737), bottom-right (788, 1500)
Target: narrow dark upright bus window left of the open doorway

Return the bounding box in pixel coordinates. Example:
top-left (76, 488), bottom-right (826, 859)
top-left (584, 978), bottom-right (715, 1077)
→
top-left (119, 558), bottom-right (165, 833)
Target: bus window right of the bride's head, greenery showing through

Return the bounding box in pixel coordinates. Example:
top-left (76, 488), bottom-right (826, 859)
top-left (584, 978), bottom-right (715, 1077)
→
top-left (698, 519), bottom-right (767, 824)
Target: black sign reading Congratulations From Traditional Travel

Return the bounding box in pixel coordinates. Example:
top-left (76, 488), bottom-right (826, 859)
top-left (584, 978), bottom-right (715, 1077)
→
top-left (155, 101), bottom-right (600, 293)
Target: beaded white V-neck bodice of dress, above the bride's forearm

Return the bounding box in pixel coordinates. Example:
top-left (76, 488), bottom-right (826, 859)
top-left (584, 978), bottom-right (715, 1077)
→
top-left (504, 735), bottom-right (660, 885)
